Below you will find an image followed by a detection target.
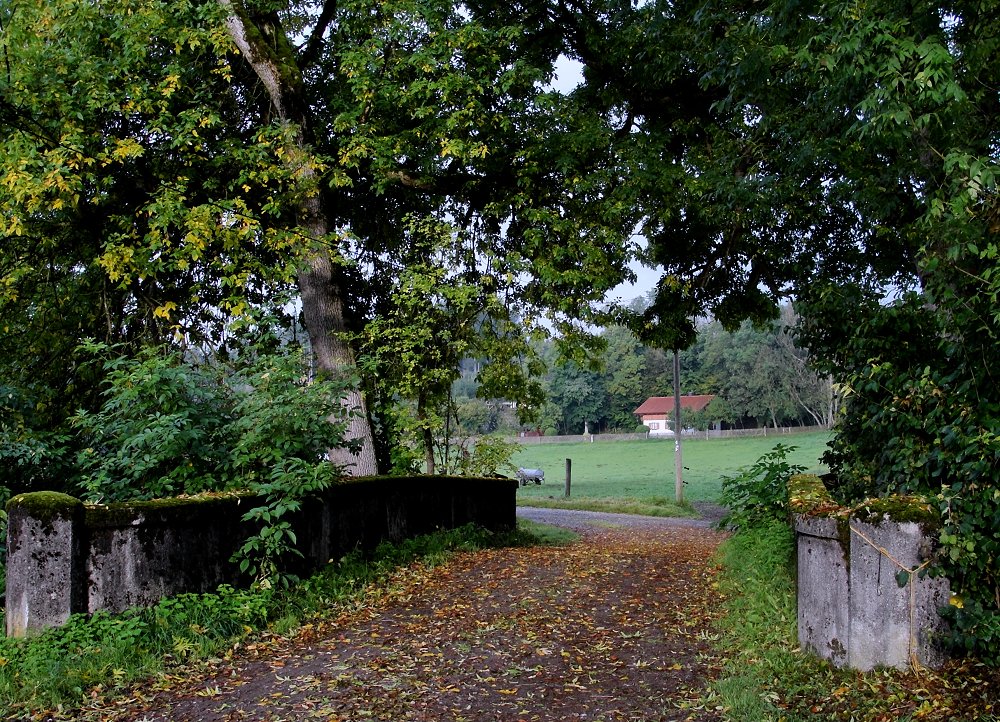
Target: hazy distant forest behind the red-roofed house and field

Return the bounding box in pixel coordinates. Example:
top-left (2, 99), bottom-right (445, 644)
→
top-left (452, 299), bottom-right (838, 435)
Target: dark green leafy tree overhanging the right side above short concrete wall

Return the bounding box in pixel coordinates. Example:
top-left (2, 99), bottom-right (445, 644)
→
top-left (581, 0), bottom-right (1000, 659)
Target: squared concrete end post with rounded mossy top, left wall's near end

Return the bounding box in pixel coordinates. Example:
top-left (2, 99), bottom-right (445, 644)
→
top-left (7, 492), bottom-right (86, 637)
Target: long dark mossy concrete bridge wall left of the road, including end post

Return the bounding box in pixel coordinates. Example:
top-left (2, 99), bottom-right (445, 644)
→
top-left (6, 476), bottom-right (517, 636)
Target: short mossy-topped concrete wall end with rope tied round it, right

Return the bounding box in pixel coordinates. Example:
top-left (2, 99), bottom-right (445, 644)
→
top-left (789, 474), bottom-right (950, 671)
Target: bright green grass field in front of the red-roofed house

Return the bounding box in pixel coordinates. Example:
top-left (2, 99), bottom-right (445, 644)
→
top-left (513, 432), bottom-right (830, 516)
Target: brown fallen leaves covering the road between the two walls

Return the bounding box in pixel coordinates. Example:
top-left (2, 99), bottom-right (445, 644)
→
top-left (72, 525), bottom-right (723, 722)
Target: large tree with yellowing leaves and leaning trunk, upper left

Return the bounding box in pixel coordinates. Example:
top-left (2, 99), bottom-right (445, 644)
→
top-left (0, 0), bottom-right (631, 473)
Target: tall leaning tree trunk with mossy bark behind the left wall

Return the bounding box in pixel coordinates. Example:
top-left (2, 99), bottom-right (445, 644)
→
top-left (218, 0), bottom-right (378, 476)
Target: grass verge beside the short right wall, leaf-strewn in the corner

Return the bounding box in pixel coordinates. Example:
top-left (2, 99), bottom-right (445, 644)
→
top-left (703, 523), bottom-right (1000, 722)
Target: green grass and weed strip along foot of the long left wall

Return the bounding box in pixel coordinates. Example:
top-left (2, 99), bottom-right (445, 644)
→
top-left (0, 523), bottom-right (571, 720)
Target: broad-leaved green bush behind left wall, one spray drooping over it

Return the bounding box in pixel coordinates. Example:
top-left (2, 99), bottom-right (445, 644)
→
top-left (68, 343), bottom-right (356, 587)
